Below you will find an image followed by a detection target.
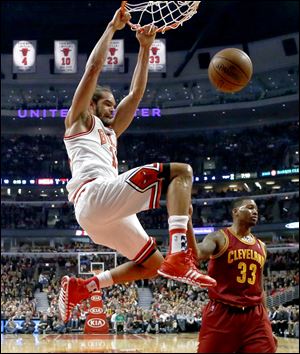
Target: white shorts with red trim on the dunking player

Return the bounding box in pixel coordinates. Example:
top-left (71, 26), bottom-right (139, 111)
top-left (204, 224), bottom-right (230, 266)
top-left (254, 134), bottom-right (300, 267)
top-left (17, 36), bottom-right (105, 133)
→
top-left (74, 163), bottom-right (163, 263)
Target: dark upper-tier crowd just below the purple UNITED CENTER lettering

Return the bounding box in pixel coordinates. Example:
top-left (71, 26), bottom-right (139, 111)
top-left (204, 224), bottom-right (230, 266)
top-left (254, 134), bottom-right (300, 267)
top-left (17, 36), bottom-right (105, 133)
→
top-left (1, 122), bottom-right (299, 178)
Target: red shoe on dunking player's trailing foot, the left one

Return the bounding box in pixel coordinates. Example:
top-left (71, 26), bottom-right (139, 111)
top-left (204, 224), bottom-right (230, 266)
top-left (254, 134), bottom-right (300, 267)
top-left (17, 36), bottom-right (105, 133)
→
top-left (58, 275), bottom-right (99, 322)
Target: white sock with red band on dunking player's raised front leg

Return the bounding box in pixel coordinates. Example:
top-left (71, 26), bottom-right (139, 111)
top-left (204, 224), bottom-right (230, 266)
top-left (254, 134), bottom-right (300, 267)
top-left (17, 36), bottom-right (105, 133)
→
top-left (168, 215), bottom-right (189, 254)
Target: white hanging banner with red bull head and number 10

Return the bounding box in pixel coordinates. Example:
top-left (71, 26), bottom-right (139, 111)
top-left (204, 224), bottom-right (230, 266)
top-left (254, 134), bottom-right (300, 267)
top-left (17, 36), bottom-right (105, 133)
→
top-left (54, 40), bottom-right (78, 74)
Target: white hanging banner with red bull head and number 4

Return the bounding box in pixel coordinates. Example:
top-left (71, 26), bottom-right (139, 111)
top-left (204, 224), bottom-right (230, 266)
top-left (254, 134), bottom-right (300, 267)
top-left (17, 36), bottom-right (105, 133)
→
top-left (13, 41), bottom-right (36, 74)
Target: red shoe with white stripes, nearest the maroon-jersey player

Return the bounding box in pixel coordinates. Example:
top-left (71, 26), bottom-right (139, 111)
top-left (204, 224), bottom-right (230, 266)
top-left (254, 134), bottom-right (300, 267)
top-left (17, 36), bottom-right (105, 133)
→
top-left (157, 248), bottom-right (217, 287)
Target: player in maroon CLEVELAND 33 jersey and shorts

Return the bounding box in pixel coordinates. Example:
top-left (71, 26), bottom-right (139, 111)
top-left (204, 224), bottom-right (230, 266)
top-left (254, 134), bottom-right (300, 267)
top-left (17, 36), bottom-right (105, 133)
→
top-left (188, 198), bottom-right (277, 353)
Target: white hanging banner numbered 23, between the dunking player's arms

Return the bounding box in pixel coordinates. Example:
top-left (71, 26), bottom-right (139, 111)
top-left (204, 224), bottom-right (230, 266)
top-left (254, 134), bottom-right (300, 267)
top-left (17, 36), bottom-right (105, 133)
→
top-left (102, 39), bottom-right (124, 73)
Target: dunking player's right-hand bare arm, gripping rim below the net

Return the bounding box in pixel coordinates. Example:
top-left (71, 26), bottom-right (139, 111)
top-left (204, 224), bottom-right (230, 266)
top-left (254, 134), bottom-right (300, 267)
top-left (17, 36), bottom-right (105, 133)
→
top-left (112, 25), bottom-right (156, 137)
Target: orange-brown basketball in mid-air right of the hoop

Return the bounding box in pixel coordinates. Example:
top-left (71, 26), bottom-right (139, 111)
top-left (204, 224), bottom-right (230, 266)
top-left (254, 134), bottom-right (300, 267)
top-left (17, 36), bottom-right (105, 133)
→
top-left (208, 48), bottom-right (253, 92)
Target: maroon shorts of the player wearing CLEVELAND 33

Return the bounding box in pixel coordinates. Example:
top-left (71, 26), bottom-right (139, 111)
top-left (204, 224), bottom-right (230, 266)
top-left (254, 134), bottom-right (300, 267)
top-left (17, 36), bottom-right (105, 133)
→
top-left (198, 301), bottom-right (276, 353)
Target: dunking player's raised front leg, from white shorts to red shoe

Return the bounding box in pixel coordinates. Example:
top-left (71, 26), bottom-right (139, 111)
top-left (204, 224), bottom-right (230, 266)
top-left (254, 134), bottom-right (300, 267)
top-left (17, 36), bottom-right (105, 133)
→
top-left (75, 163), bottom-right (216, 286)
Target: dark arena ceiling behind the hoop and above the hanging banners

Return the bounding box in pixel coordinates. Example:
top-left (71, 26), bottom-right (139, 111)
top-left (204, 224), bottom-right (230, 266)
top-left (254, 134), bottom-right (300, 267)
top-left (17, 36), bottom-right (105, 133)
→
top-left (1, 0), bottom-right (299, 54)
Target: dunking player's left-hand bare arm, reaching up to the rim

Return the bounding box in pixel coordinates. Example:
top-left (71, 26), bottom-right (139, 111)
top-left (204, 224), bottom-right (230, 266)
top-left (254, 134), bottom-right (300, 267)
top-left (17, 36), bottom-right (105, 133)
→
top-left (65, 9), bottom-right (130, 128)
